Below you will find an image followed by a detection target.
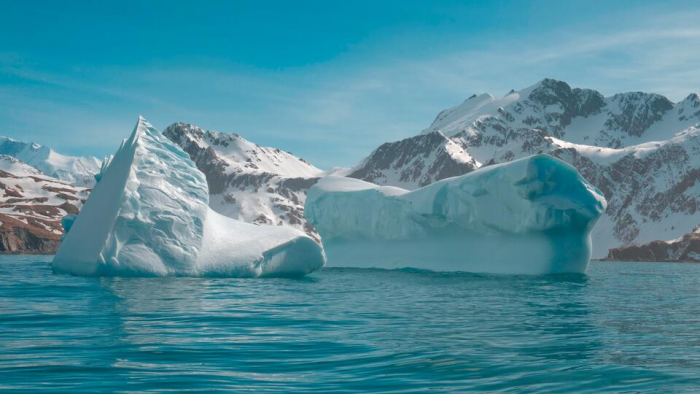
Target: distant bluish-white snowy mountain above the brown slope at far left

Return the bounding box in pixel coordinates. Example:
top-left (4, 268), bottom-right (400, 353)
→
top-left (0, 137), bottom-right (101, 187)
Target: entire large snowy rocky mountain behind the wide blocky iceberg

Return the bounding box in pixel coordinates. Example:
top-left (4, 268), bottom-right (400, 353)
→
top-left (350, 79), bottom-right (700, 257)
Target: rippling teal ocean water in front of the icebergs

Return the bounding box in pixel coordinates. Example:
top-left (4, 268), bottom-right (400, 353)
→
top-left (0, 256), bottom-right (700, 393)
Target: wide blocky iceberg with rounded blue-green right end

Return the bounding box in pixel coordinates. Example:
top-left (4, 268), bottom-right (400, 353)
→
top-left (305, 155), bottom-right (606, 275)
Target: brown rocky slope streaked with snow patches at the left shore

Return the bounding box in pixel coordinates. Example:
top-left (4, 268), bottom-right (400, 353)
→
top-left (0, 155), bottom-right (89, 253)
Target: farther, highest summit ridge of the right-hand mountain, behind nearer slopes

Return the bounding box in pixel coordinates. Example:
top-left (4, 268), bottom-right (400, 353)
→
top-left (423, 79), bottom-right (700, 149)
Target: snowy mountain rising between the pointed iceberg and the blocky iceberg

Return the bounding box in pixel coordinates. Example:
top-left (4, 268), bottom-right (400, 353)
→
top-left (163, 123), bottom-right (324, 241)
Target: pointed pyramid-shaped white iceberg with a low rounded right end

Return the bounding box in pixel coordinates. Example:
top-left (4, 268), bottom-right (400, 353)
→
top-left (53, 117), bottom-right (325, 277)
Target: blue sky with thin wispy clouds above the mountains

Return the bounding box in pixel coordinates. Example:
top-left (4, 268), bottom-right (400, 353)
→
top-left (0, 0), bottom-right (700, 168)
